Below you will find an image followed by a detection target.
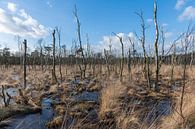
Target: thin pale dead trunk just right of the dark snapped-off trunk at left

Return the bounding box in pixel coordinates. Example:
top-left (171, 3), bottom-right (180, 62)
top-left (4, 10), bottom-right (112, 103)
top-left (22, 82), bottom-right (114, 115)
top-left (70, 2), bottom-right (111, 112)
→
top-left (56, 27), bottom-right (62, 82)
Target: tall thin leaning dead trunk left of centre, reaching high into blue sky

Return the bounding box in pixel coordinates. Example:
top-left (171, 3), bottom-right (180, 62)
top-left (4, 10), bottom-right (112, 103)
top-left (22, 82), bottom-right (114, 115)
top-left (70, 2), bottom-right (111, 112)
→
top-left (73, 5), bottom-right (87, 78)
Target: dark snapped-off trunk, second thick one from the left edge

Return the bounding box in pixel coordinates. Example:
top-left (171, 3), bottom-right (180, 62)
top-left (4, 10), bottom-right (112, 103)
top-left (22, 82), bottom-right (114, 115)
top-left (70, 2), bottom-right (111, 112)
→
top-left (52, 30), bottom-right (57, 84)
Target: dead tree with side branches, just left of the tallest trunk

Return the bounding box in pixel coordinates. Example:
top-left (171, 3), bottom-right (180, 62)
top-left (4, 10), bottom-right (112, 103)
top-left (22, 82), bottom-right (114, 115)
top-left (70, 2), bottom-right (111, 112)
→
top-left (136, 11), bottom-right (151, 88)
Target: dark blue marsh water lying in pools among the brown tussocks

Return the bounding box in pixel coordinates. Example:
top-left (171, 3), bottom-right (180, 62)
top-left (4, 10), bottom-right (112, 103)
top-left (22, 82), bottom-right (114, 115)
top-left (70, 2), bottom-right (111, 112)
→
top-left (0, 76), bottom-right (172, 129)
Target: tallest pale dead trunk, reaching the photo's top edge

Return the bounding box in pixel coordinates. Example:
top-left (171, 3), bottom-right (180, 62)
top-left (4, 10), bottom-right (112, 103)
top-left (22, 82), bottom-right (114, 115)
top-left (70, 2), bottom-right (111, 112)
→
top-left (154, 1), bottom-right (159, 91)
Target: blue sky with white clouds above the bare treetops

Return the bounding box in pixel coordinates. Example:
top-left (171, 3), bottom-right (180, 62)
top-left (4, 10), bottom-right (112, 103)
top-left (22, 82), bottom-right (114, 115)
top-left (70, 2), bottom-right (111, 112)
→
top-left (0, 0), bottom-right (195, 51)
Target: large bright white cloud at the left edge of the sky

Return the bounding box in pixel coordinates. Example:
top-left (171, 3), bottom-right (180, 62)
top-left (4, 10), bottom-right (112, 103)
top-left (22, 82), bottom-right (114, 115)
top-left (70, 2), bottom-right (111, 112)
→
top-left (0, 8), bottom-right (49, 38)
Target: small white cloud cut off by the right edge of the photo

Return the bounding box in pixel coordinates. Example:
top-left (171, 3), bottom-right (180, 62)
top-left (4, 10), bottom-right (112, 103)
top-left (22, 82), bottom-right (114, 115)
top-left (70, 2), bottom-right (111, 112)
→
top-left (179, 6), bottom-right (195, 21)
